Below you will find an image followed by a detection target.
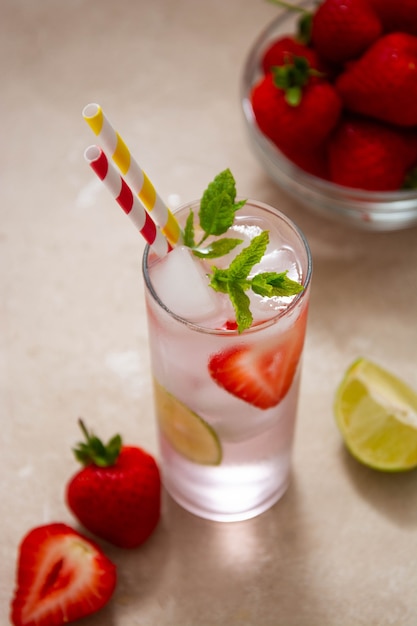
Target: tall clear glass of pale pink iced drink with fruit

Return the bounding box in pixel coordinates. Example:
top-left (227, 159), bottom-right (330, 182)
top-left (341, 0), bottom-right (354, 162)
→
top-left (143, 201), bottom-right (311, 521)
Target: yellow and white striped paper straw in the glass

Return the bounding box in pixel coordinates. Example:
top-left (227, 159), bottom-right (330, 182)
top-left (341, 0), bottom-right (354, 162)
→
top-left (83, 103), bottom-right (181, 246)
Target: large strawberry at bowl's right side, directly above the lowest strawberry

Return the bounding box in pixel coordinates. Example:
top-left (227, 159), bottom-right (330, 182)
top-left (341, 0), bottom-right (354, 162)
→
top-left (335, 33), bottom-right (417, 126)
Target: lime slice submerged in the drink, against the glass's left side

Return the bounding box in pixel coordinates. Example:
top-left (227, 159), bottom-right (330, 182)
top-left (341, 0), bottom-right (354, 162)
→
top-left (154, 381), bottom-right (222, 465)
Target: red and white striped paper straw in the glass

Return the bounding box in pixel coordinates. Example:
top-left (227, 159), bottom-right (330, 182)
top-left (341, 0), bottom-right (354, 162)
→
top-left (84, 146), bottom-right (172, 257)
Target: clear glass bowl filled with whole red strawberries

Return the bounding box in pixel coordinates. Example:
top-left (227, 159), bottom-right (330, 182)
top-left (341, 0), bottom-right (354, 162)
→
top-left (242, 0), bottom-right (417, 230)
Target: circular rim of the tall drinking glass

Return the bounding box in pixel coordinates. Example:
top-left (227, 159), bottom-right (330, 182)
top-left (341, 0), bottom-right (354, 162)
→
top-left (142, 198), bottom-right (313, 336)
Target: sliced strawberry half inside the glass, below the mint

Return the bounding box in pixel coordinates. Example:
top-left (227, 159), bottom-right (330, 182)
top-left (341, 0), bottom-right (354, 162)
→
top-left (208, 311), bottom-right (306, 409)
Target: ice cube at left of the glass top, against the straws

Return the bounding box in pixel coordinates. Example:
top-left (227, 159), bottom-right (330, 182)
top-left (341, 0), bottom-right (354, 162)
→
top-left (151, 246), bottom-right (220, 322)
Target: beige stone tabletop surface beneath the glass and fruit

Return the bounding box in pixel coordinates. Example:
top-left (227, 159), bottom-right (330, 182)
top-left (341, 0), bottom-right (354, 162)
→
top-left (0, 0), bottom-right (417, 626)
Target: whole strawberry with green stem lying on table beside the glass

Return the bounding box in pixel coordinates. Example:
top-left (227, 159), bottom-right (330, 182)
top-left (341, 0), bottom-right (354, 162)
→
top-left (66, 420), bottom-right (161, 548)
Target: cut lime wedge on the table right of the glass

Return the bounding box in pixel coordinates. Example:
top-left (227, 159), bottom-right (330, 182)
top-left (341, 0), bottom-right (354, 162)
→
top-left (334, 358), bottom-right (417, 472)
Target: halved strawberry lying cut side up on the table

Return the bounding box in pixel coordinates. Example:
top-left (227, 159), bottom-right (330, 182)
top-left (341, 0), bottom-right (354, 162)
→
top-left (10, 523), bottom-right (116, 626)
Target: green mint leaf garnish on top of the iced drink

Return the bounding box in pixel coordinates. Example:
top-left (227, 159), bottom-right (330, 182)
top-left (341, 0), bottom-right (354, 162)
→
top-left (178, 169), bottom-right (304, 333)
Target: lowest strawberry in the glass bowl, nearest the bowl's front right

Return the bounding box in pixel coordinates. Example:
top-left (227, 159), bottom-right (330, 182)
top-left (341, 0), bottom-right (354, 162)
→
top-left (328, 117), bottom-right (417, 191)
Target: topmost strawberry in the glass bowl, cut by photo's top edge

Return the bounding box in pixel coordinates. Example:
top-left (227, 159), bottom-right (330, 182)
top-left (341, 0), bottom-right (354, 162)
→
top-left (311, 0), bottom-right (382, 64)
